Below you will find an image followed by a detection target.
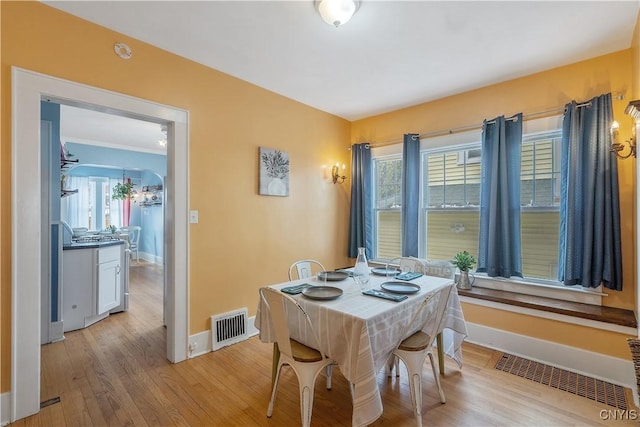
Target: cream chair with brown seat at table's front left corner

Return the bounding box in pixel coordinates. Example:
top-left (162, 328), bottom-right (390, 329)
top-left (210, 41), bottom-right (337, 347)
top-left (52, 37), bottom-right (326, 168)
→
top-left (260, 287), bottom-right (335, 427)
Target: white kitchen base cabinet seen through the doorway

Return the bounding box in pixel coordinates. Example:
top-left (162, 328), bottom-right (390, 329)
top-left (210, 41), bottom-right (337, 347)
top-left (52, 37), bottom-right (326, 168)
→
top-left (62, 244), bottom-right (124, 332)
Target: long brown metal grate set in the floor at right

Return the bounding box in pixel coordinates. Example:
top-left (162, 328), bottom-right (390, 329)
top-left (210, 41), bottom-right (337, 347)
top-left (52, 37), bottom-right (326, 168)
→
top-left (495, 353), bottom-right (627, 410)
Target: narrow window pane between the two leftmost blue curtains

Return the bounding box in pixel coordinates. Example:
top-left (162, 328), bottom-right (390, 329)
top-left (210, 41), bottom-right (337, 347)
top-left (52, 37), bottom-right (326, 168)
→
top-left (373, 157), bottom-right (402, 259)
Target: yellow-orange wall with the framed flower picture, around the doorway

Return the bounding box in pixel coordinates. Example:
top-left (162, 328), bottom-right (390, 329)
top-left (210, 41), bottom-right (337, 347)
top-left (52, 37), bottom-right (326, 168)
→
top-left (0, 2), bottom-right (350, 392)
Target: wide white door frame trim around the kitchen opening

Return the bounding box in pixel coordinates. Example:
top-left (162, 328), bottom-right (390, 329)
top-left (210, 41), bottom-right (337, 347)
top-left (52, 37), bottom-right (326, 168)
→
top-left (10, 67), bottom-right (189, 422)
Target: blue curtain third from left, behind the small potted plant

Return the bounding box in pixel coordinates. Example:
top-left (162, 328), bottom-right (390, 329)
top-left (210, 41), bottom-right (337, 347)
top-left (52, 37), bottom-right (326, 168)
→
top-left (476, 113), bottom-right (522, 277)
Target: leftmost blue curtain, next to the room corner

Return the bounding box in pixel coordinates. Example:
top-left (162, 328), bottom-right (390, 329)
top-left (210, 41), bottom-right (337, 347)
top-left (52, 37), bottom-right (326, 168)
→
top-left (348, 143), bottom-right (373, 259)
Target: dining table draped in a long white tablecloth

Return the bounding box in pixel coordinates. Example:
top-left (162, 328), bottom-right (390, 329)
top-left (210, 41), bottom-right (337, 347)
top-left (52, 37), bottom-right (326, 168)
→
top-left (255, 271), bottom-right (467, 426)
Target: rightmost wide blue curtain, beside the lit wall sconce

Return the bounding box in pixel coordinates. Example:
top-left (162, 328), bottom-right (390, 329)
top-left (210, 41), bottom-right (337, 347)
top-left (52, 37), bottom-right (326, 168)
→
top-left (558, 93), bottom-right (622, 291)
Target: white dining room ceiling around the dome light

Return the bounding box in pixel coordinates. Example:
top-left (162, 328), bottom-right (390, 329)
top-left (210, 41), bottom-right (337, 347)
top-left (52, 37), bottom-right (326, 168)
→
top-left (45, 0), bottom-right (640, 152)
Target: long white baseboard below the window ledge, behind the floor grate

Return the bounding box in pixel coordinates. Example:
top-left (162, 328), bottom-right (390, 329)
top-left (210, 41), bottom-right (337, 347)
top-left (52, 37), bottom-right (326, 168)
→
top-left (467, 322), bottom-right (637, 396)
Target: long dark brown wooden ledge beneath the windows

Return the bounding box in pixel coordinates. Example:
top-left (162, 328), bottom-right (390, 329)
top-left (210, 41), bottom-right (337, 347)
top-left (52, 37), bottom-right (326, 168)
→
top-left (458, 286), bottom-right (638, 328)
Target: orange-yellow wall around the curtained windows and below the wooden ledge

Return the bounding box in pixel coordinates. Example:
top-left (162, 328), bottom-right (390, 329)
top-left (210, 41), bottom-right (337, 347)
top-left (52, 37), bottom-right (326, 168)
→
top-left (351, 49), bottom-right (638, 359)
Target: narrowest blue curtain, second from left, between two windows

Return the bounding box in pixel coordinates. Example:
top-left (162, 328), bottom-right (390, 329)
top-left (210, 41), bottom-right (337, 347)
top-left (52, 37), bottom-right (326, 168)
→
top-left (402, 133), bottom-right (420, 257)
